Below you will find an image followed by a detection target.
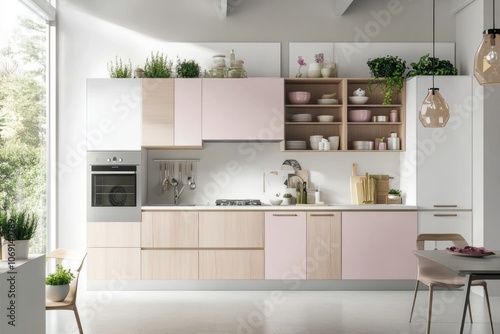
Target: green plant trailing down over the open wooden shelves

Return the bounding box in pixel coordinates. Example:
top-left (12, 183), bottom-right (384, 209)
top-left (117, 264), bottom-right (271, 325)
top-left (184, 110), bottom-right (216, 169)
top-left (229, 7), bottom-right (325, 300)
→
top-left (367, 55), bottom-right (407, 105)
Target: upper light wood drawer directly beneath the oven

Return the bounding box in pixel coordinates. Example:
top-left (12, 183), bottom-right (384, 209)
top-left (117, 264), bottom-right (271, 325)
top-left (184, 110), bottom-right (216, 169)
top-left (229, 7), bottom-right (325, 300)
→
top-left (87, 222), bottom-right (141, 247)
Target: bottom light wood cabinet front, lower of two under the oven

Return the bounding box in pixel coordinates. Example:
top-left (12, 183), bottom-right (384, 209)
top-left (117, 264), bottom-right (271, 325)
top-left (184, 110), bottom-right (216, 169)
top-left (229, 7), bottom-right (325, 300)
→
top-left (87, 247), bottom-right (141, 280)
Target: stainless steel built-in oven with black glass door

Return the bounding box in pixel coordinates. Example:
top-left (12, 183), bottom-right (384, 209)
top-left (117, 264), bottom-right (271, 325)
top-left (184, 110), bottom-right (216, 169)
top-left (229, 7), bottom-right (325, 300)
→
top-left (87, 151), bottom-right (141, 222)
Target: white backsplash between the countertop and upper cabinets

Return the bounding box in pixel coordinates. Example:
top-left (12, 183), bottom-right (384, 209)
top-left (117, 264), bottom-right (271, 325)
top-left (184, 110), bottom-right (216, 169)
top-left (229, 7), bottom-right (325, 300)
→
top-left (143, 142), bottom-right (404, 205)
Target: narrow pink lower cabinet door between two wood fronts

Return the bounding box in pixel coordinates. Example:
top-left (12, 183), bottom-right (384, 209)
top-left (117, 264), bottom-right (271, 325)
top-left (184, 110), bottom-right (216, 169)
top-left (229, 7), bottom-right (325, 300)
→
top-left (264, 211), bottom-right (307, 279)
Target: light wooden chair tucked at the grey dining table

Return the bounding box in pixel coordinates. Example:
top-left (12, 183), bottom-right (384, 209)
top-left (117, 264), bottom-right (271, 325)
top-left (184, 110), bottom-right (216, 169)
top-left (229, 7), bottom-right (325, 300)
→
top-left (409, 233), bottom-right (493, 334)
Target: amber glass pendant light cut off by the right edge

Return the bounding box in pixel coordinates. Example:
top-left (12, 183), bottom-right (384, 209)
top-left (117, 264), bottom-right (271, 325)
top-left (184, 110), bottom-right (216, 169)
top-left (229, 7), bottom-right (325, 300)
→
top-left (474, 0), bottom-right (500, 85)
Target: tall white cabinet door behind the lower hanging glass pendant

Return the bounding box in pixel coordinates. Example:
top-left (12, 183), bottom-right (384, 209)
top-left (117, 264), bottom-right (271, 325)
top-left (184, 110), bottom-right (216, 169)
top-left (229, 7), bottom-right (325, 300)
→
top-left (402, 76), bottom-right (472, 210)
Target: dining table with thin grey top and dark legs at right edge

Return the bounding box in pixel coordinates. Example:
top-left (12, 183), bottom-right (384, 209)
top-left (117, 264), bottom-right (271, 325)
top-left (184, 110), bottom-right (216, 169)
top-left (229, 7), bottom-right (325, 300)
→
top-left (413, 250), bottom-right (500, 334)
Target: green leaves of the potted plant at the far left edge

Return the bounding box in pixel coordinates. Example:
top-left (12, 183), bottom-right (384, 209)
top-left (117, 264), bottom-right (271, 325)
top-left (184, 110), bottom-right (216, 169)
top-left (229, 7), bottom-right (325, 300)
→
top-left (0, 209), bottom-right (38, 240)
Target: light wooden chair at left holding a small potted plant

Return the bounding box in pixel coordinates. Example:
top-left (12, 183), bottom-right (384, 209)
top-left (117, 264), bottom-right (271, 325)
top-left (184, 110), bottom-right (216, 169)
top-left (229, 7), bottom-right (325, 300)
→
top-left (45, 248), bottom-right (87, 334)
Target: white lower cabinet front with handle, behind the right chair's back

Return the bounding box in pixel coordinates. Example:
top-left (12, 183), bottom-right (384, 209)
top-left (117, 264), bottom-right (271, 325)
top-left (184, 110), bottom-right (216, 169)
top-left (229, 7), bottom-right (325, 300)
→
top-left (418, 211), bottom-right (472, 249)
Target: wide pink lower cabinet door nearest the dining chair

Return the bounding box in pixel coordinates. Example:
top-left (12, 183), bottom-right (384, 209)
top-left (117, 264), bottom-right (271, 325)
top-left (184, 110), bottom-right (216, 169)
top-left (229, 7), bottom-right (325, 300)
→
top-left (342, 211), bottom-right (417, 279)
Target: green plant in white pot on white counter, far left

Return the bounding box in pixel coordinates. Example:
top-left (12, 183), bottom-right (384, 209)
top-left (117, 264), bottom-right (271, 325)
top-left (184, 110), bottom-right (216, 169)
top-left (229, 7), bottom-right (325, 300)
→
top-left (0, 209), bottom-right (38, 260)
